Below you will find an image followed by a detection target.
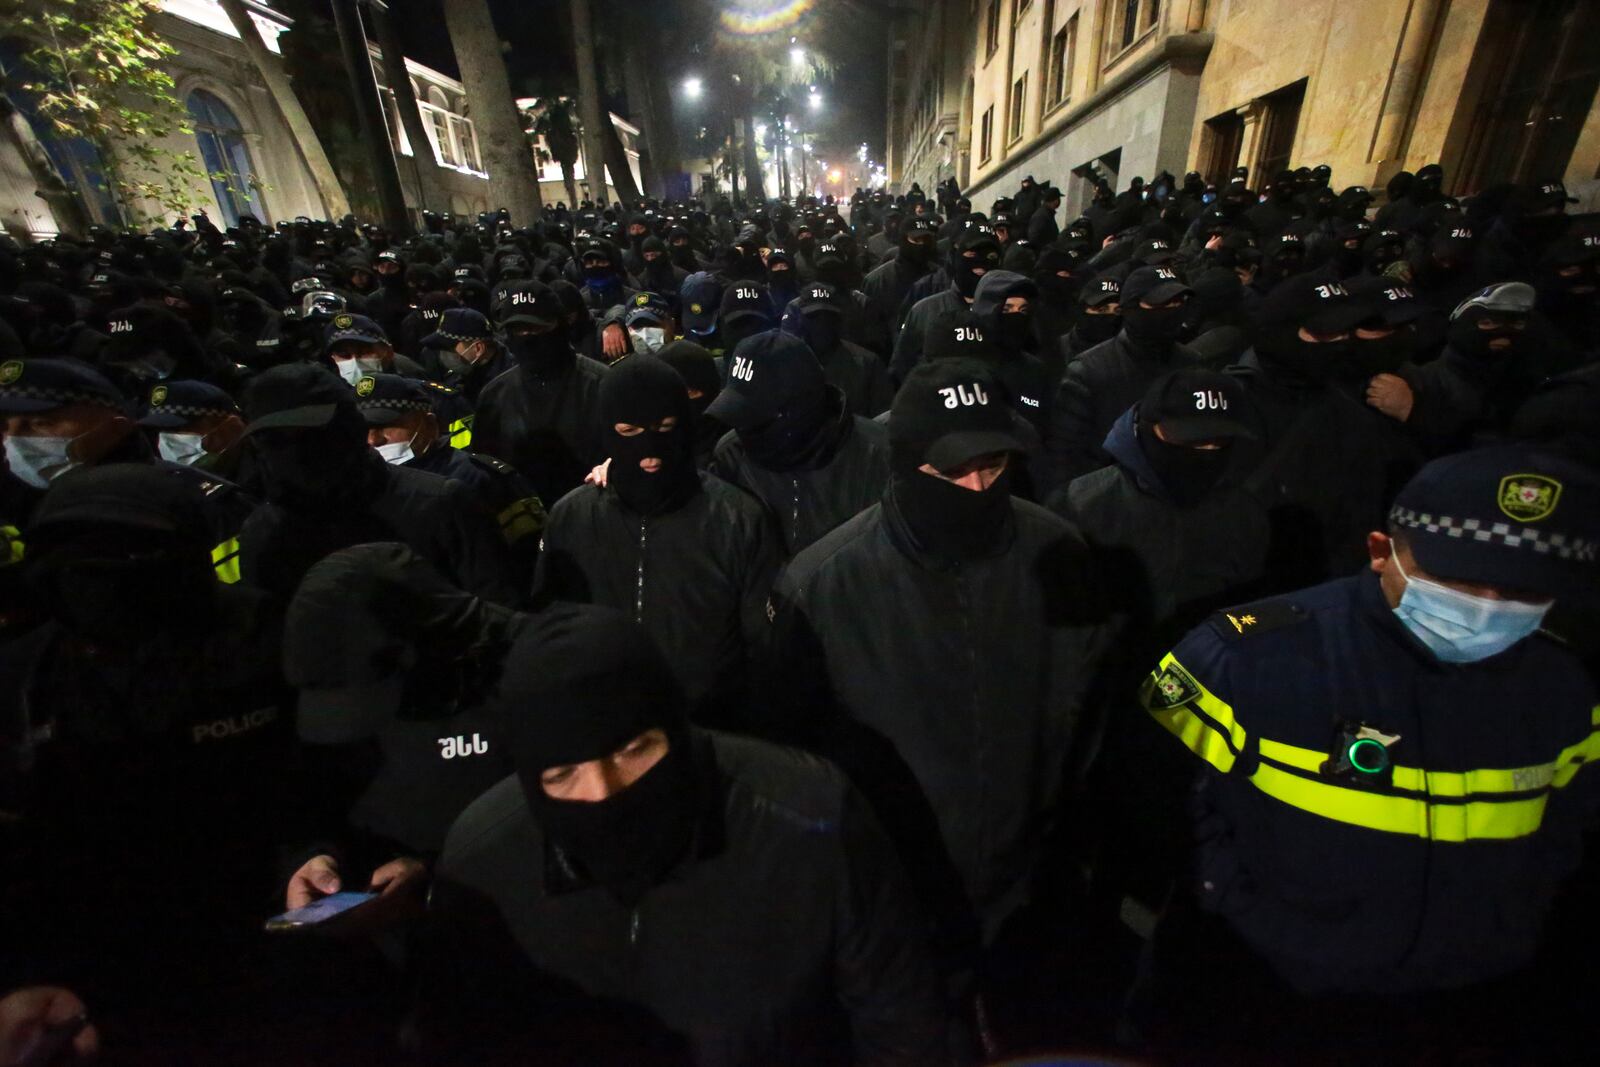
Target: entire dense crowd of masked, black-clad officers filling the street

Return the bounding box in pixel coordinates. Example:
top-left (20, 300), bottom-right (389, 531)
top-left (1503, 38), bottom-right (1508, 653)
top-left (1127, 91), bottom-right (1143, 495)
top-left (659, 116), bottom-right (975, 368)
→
top-left (0, 166), bottom-right (1600, 1067)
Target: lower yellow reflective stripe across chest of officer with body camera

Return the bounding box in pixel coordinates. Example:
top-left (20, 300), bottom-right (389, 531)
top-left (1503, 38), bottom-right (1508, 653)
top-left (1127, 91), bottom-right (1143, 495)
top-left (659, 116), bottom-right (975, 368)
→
top-left (1250, 761), bottom-right (1549, 841)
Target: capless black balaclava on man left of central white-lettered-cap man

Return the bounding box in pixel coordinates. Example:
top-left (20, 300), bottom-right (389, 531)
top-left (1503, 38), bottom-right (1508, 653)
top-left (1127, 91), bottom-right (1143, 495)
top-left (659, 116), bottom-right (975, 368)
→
top-left (600, 355), bottom-right (699, 515)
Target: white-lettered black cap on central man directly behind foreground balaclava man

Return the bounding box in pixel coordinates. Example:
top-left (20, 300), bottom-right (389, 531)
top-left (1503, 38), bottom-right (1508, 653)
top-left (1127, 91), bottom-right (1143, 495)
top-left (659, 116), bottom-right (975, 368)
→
top-left (890, 358), bottom-right (1038, 470)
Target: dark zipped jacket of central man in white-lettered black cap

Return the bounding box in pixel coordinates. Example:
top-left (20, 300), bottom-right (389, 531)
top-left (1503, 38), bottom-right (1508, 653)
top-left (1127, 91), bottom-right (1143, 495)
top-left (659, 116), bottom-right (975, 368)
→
top-left (773, 489), bottom-right (1106, 937)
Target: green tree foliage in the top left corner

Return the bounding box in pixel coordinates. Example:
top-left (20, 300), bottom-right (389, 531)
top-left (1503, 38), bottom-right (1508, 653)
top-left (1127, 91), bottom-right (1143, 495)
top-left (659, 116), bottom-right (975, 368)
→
top-left (5, 0), bottom-right (219, 227)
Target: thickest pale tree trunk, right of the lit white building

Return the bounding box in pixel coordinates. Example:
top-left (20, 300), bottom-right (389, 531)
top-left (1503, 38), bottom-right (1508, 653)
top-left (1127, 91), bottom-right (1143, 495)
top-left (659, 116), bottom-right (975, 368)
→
top-left (443, 0), bottom-right (544, 226)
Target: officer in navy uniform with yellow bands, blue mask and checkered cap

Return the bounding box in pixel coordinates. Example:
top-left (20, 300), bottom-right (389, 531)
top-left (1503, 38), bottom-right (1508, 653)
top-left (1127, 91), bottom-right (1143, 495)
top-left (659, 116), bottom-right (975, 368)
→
top-left (1142, 446), bottom-right (1600, 1062)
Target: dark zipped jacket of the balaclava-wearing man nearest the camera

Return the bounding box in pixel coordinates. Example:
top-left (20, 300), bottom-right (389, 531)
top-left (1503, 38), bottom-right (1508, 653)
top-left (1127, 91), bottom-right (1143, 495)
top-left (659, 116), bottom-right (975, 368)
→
top-left (422, 731), bottom-right (947, 1067)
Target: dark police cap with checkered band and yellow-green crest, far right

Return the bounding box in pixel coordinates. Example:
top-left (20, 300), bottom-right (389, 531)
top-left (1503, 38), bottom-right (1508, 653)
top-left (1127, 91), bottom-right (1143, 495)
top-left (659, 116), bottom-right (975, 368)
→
top-left (1389, 445), bottom-right (1600, 597)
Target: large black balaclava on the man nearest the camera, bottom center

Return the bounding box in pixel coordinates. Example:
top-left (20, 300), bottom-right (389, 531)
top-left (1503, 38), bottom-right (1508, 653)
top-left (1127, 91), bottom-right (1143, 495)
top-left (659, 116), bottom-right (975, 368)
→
top-left (498, 605), bottom-right (702, 907)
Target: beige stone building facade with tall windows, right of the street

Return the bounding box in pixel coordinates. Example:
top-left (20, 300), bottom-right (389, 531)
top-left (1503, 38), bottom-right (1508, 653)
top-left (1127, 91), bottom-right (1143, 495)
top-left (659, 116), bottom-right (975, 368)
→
top-left (888, 0), bottom-right (1600, 218)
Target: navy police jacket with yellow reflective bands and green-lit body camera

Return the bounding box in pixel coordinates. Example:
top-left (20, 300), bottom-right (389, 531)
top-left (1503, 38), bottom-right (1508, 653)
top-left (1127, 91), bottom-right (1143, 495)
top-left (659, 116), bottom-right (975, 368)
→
top-left (1142, 574), bottom-right (1600, 993)
